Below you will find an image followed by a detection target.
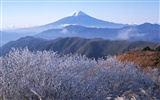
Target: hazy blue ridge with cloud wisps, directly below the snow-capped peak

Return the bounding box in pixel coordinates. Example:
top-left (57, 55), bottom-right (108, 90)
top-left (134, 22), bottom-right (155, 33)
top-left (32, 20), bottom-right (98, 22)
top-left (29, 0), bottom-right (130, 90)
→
top-left (35, 23), bottom-right (160, 43)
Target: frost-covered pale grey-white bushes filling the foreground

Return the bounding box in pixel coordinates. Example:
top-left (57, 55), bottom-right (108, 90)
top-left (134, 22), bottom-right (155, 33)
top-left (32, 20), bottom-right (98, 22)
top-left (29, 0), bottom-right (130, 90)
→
top-left (0, 48), bottom-right (160, 100)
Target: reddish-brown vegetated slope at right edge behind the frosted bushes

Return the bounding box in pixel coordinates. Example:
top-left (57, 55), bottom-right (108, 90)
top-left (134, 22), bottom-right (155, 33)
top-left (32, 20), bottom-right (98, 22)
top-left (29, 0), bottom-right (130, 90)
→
top-left (117, 50), bottom-right (160, 69)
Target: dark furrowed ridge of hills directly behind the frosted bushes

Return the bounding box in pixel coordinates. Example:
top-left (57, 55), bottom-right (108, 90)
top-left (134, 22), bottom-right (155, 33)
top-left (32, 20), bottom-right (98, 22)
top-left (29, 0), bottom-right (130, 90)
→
top-left (0, 36), bottom-right (159, 58)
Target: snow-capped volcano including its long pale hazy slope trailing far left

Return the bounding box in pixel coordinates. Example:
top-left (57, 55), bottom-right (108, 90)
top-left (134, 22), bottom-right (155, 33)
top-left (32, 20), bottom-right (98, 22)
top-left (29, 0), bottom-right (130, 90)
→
top-left (5, 11), bottom-right (126, 33)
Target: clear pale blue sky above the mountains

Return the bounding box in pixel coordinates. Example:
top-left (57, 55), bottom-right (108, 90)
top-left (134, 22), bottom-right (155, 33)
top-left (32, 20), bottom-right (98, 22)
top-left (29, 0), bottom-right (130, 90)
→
top-left (1, 0), bottom-right (160, 27)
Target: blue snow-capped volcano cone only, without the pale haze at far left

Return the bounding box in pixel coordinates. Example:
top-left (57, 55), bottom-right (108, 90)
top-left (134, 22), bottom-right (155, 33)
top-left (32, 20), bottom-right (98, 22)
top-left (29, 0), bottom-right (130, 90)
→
top-left (44, 11), bottom-right (124, 28)
